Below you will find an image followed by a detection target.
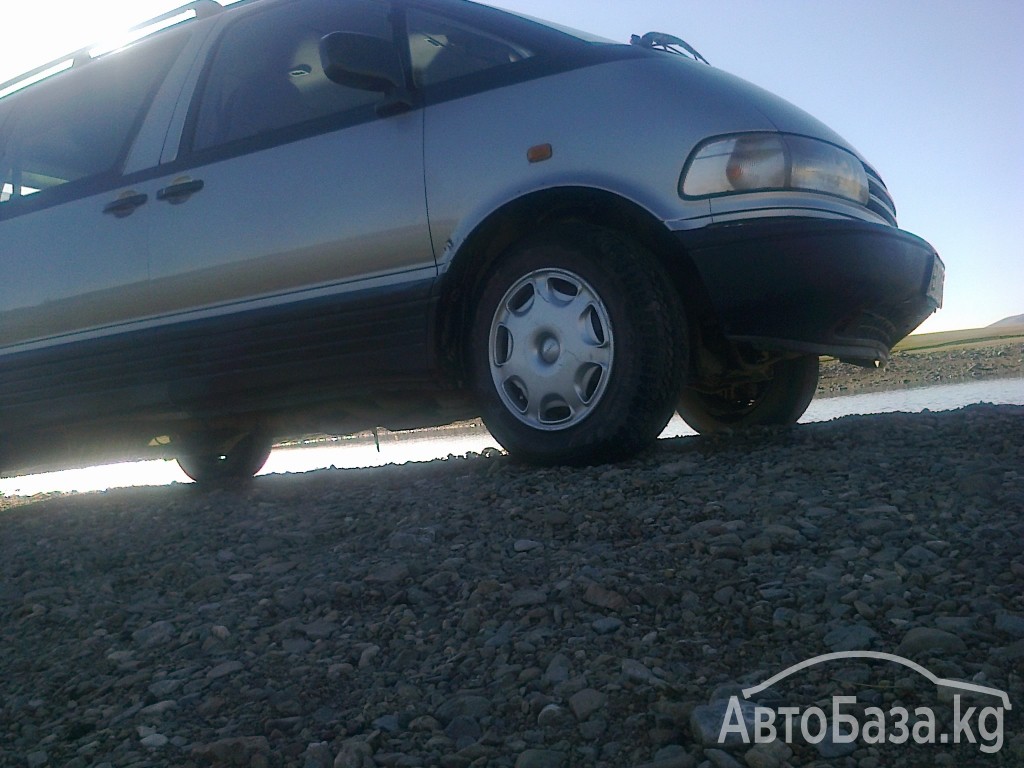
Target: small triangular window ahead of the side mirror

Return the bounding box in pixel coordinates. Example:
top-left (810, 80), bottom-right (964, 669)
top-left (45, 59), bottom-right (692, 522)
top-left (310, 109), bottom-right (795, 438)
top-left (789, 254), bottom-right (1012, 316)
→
top-left (409, 9), bottom-right (534, 87)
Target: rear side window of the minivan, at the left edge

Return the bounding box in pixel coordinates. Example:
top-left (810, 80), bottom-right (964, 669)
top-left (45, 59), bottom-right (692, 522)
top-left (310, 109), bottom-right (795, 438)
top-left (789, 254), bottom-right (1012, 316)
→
top-left (0, 34), bottom-right (186, 203)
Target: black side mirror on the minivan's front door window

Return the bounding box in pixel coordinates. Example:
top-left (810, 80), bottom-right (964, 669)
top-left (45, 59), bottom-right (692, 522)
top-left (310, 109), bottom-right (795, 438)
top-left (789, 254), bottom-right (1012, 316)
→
top-left (319, 32), bottom-right (402, 93)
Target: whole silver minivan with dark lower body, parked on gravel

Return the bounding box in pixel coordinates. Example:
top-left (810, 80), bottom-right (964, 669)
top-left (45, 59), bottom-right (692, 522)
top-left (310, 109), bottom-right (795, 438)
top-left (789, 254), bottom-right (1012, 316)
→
top-left (0, 0), bottom-right (943, 481)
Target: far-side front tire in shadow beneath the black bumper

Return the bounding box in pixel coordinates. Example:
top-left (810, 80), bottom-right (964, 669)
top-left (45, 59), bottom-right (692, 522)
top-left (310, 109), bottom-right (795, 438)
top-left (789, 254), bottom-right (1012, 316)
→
top-left (679, 355), bottom-right (818, 434)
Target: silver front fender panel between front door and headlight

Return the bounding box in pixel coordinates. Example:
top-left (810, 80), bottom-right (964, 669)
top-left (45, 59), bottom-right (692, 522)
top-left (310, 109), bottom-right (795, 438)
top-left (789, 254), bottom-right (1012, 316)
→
top-left (424, 58), bottom-right (774, 269)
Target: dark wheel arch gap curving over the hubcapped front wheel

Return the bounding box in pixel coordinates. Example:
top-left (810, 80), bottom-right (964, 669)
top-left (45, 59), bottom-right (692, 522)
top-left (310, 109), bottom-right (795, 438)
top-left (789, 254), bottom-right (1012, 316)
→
top-left (434, 186), bottom-right (710, 381)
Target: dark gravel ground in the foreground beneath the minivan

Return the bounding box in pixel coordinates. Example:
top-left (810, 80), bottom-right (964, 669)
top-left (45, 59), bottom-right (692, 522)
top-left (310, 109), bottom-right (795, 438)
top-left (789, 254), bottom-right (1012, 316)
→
top-left (0, 406), bottom-right (1024, 768)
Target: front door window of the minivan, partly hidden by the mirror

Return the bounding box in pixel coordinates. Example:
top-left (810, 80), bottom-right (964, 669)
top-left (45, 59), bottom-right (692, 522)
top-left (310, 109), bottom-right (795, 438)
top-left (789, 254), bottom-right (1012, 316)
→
top-left (191, 0), bottom-right (393, 151)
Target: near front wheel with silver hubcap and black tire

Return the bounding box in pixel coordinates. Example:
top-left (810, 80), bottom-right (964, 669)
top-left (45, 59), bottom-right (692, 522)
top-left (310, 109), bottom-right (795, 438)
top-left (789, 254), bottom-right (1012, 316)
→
top-left (469, 219), bottom-right (686, 465)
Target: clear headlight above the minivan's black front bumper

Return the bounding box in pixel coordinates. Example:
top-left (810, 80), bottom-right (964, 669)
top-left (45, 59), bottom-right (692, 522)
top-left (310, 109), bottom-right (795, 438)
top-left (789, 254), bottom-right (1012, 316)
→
top-left (679, 133), bottom-right (868, 205)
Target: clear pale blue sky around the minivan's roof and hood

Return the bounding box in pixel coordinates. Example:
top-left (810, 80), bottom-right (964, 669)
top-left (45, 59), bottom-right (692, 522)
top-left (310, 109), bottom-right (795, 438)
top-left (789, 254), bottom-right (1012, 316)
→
top-left (0, 0), bottom-right (1024, 332)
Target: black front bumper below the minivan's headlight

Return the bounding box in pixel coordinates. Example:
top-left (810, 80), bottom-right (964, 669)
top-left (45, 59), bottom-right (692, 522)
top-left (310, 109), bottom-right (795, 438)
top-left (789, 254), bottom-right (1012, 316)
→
top-left (676, 219), bottom-right (945, 362)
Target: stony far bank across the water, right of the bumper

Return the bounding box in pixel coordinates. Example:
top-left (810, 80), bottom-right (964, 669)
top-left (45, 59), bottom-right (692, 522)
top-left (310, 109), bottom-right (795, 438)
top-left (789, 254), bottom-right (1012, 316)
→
top-left (818, 341), bottom-right (1024, 397)
